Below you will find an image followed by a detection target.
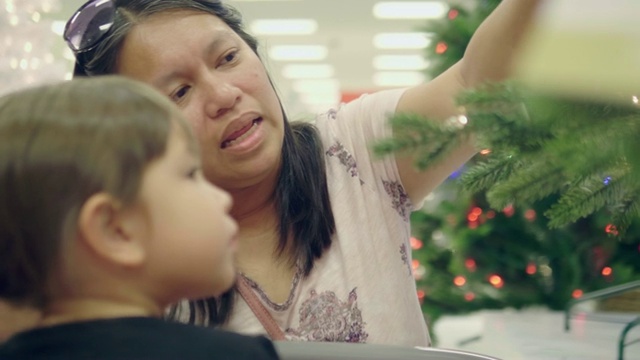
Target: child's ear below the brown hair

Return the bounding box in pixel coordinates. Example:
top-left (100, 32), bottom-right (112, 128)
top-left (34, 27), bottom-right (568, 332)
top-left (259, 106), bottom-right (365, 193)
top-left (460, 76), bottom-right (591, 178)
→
top-left (78, 193), bottom-right (146, 267)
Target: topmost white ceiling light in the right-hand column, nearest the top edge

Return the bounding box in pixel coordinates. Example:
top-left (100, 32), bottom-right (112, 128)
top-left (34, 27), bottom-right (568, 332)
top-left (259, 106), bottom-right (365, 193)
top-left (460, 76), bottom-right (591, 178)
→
top-left (373, 1), bottom-right (449, 19)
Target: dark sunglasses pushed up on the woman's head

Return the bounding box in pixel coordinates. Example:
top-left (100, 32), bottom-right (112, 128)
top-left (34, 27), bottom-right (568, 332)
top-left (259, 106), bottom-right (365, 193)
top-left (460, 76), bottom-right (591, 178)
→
top-left (63, 0), bottom-right (116, 54)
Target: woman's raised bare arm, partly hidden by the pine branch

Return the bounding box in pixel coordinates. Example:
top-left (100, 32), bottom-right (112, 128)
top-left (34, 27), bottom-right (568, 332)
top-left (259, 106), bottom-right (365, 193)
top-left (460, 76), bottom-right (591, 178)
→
top-left (396, 0), bottom-right (542, 203)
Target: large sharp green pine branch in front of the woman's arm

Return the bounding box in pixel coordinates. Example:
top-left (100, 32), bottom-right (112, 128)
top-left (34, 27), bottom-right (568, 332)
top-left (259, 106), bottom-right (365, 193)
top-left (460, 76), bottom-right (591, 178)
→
top-left (374, 82), bottom-right (640, 233)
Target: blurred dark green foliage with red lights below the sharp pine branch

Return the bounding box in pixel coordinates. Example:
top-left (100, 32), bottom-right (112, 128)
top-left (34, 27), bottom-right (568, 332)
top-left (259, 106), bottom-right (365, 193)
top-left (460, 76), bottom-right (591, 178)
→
top-left (411, 186), bottom-right (640, 332)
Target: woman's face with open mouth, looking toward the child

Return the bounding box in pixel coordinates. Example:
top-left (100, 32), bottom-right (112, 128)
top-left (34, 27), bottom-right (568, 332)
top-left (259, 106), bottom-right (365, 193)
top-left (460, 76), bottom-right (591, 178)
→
top-left (117, 11), bottom-right (284, 191)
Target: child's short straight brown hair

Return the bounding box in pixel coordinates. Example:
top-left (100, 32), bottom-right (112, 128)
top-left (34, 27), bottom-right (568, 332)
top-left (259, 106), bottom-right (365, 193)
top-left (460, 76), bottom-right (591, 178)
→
top-left (0, 76), bottom-right (190, 307)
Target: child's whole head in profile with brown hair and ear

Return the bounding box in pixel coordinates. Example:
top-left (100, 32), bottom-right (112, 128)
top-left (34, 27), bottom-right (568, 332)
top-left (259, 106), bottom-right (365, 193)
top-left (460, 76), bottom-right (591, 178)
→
top-left (0, 77), bottom-right (237, 314)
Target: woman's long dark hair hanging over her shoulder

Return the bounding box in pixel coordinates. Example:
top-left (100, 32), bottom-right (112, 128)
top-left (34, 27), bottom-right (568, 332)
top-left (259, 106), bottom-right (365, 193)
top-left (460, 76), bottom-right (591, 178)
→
top-left (74, 0), bottom-right (335, 324)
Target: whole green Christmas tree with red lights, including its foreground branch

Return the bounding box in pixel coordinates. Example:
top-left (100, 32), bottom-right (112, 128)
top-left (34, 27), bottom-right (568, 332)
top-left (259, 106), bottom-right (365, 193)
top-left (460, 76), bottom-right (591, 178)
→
top-left (377, 0), bottom-right (640, 332)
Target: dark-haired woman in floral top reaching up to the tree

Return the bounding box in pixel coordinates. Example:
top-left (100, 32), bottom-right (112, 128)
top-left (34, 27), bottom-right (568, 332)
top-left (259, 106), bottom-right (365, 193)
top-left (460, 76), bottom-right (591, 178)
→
top-left (58, 0), bottom-right (538, 346)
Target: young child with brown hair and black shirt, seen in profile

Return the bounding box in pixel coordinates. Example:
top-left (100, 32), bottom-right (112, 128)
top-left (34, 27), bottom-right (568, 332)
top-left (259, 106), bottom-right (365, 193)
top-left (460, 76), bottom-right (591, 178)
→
top-left (0, 76), bottom-right (278, 359)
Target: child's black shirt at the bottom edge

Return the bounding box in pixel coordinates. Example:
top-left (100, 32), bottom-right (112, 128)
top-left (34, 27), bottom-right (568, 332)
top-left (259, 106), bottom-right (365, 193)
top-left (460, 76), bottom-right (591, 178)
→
top-left (0, 317), bottom-right (278, 360)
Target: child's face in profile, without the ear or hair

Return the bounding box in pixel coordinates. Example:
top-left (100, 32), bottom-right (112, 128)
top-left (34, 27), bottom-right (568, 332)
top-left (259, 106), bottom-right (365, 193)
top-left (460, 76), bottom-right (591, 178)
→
top-left (131, 126), bottom-right (238, 301)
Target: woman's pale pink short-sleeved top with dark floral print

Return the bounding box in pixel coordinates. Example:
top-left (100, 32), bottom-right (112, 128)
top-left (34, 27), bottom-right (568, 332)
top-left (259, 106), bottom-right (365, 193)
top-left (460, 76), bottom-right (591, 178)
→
top-left (226, 89), bottom-right (430, 346)
